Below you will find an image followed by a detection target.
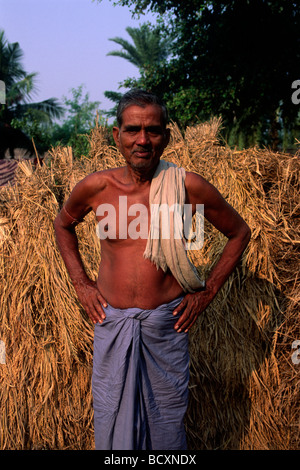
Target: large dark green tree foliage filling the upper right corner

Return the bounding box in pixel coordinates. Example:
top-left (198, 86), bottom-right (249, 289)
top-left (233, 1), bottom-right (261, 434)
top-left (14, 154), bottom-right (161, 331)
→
top-left (99, 0), bottom-right (300, 148)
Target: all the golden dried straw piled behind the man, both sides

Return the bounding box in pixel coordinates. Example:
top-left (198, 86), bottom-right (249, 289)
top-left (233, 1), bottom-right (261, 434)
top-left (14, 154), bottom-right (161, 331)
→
top-left (0, 119), bottom-right (300, 449)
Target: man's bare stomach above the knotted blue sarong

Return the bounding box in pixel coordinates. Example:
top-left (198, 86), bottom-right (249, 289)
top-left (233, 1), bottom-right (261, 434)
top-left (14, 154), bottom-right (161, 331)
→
top-left (97, 244), bottom-right (183, 309)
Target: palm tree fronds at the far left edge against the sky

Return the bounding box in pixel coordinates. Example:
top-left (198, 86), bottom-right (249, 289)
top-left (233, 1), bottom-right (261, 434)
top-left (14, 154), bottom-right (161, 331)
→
top-left (0, 30), bottom-right (63, 124)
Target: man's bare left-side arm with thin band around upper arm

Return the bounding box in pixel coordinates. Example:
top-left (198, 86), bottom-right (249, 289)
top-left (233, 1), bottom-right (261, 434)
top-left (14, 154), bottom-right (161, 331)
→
top-left (54, 177), bottom-right (106, 323)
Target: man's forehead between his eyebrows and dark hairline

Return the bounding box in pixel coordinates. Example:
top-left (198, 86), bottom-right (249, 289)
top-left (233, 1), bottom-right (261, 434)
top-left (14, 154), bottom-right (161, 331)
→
top-left (122, 104), bottom-right (163, 126)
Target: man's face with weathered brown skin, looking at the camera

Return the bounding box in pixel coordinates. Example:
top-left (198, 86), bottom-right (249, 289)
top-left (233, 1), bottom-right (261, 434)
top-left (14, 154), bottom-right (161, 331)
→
top-left (113, 105), bottom-right (170, 171)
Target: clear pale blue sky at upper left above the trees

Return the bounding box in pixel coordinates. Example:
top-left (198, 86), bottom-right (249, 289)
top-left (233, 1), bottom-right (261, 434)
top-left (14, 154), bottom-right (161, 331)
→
top-left (0, 0), bottom-right (155, 115)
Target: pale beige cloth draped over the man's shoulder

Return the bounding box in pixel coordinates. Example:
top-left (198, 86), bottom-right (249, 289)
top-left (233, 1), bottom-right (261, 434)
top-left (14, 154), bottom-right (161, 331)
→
top-left (144, 160), bottom-right (205, 292)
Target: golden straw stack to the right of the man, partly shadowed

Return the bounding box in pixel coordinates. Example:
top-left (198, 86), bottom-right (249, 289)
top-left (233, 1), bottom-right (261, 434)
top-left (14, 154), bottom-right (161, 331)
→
top-left (167, 119), bottom-right (300, 449)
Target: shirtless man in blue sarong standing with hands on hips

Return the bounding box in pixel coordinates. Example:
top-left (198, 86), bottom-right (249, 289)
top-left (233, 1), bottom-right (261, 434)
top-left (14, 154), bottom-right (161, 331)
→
top-left (54, 90), bottom-right (250, 450)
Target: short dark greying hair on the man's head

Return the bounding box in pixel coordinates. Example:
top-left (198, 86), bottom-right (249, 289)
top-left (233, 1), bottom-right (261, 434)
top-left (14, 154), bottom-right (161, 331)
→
top-left (117, 88), bottom-right (169, 127)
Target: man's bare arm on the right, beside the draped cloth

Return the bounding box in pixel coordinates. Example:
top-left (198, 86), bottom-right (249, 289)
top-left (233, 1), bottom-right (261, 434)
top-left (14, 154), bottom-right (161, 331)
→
top-left (173, 173), bottom-right (251, 332)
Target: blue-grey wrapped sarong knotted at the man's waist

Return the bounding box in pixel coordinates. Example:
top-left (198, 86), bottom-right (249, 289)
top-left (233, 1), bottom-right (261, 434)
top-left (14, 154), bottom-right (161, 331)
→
top-left (92, 298), bottom-right (189, 450)
